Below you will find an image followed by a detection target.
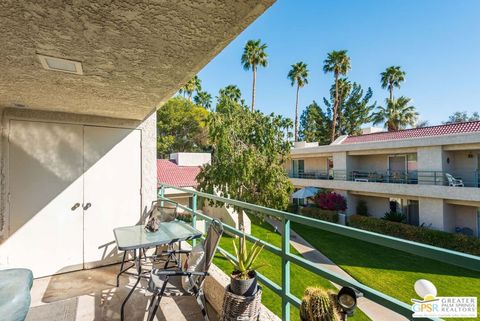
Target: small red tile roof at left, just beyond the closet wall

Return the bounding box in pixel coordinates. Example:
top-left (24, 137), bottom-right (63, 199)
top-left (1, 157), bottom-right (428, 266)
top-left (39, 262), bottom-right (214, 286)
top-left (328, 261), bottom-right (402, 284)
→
top-left (157, 159), bottom-right (200, 187)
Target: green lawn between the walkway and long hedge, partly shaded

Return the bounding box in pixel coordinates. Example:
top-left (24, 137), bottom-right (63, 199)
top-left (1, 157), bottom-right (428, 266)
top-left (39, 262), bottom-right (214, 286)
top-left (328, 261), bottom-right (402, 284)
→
top-left (292, 223), bottom-right (480, 320)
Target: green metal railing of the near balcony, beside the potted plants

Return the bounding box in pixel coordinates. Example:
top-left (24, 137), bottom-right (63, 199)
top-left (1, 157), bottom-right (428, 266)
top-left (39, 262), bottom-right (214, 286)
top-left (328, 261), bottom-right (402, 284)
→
top-left (158, 183), bottom-right (480, 321)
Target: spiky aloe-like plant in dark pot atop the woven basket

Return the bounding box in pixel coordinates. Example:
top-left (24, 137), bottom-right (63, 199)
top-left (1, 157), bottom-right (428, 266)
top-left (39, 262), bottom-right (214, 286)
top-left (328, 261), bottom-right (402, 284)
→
top-left (222, 234), bottom-right (263, 297)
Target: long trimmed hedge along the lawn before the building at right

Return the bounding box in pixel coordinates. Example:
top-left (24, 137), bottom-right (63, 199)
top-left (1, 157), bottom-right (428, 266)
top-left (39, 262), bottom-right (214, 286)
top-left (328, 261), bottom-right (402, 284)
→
top-left (348, 215), bottom-right (480, 255)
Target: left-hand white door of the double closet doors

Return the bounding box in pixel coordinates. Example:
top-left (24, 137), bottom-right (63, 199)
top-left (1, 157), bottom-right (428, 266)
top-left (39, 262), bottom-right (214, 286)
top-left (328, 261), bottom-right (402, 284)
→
top-left (0, 120), bottom-right (83, 277)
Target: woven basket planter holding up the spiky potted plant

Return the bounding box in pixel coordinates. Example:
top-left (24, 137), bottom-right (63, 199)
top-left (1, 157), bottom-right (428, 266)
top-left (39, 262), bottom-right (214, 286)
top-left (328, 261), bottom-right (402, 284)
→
top-left (220, 286), bottom-right (262, 321)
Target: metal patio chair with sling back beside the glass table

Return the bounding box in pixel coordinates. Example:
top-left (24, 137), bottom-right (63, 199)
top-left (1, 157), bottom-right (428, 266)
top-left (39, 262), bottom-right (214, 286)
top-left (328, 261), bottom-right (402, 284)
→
top-left (147, 220), bottom-right (223, 321)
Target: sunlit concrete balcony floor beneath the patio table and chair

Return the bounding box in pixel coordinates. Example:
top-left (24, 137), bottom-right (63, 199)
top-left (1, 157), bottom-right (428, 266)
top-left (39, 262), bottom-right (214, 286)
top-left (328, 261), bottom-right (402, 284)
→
top-left (27, 264), bottom-right (217, 321)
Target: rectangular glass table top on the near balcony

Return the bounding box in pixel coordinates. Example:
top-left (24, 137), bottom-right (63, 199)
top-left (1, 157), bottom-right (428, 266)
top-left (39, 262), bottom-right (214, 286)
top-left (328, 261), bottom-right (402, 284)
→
top-left (113, 220), bottom-right (202, 251)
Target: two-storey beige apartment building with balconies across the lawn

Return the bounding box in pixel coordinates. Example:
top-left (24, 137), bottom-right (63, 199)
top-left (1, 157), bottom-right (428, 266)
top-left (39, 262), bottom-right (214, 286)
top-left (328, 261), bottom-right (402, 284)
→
top-left (287, 121), bottom-right (480, 237)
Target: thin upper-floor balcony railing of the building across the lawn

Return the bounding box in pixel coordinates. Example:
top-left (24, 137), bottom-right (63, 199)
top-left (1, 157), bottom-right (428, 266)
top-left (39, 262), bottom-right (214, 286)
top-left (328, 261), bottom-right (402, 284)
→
top-left (288, 170), bottom-right (480, 187)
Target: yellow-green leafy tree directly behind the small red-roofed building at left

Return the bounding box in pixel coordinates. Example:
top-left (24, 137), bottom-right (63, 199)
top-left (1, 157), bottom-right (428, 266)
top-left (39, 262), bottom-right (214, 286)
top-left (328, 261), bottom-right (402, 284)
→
top-left (157, 97), bottom-right (209, 157)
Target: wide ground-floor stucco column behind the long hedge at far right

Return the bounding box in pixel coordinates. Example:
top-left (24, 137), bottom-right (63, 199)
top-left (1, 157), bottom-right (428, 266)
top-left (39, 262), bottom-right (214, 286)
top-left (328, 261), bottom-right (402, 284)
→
top-left (419, 198), bottom-right (455, 232)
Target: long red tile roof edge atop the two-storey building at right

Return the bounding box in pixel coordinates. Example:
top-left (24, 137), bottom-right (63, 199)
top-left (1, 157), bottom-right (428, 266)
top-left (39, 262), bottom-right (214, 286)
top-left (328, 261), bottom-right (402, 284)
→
top-left (341, 121), bottom-right (480, 144)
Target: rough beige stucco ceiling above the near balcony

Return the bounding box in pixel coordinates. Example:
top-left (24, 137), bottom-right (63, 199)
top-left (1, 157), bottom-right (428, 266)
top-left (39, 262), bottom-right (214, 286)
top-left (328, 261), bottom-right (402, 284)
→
top-left (0, 0), bottom-right (275, 119)
